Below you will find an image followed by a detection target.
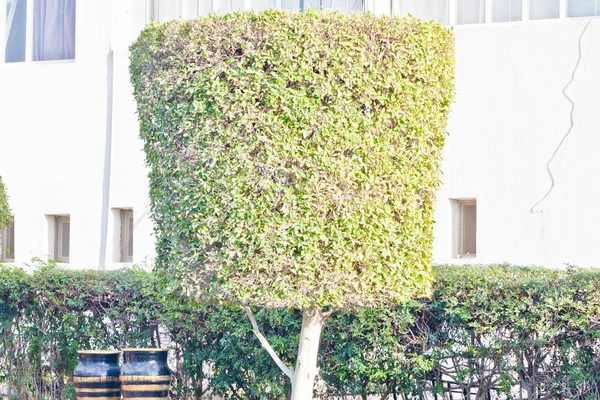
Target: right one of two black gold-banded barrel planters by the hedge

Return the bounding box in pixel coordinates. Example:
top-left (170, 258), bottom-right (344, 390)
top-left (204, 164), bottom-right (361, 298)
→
top-left (121, 349), bottom-right (171, 400)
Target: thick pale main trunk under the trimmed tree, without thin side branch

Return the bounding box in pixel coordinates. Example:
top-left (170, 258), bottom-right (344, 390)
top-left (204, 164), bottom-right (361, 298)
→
top-left (290, 307), bottom-right (325, 400)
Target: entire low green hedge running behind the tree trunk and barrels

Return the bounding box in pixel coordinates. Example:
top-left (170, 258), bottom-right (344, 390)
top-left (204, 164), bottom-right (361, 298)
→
top-left (0, 265), bottom-right (600, 400)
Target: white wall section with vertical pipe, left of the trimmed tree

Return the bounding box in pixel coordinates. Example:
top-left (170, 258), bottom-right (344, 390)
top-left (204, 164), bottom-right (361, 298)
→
top-left (0, 1), bottom-right (154, 268)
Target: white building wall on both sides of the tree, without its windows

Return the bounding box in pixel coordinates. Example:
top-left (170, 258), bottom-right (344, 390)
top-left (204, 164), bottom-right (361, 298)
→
top-left (0, 0), bottom-right (600, 268)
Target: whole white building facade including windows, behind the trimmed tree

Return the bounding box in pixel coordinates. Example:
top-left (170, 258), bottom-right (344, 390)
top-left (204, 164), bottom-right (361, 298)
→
top-left (0, 0), bottom-right (600, 269)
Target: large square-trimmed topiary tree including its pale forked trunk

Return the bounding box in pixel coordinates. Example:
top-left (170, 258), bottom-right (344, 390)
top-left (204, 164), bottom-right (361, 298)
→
top-left (130, 11), bottom-right (454, 399)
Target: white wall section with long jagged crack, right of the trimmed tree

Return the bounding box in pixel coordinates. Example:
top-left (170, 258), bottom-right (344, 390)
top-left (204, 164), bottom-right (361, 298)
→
top-left (434, 18), bottom-right (600, 266)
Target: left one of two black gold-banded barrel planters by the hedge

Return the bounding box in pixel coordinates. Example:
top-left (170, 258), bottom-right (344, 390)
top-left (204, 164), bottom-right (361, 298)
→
top-left (73, 350), bottom-right (121, 400)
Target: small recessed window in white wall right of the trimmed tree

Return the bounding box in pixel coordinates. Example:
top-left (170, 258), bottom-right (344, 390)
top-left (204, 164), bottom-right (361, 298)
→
top-left (452, 199), bottom-right (477, 258)
